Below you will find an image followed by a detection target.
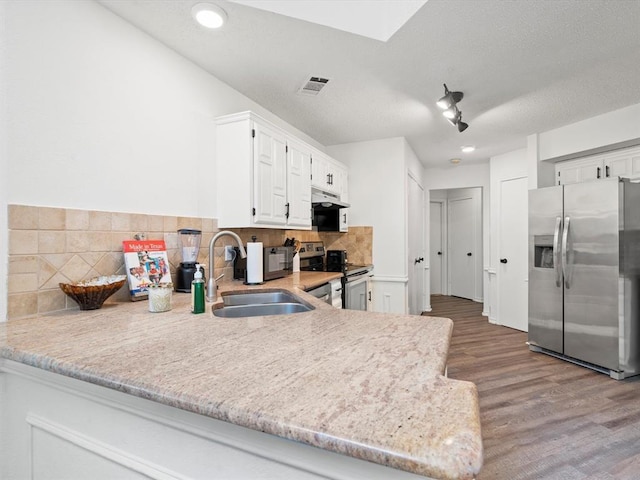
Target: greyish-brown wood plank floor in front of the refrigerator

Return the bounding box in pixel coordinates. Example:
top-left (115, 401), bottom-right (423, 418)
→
top-left (425, 296), bottom-right (640, 480)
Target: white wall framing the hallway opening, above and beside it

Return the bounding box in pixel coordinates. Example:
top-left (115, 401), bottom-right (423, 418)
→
top-left (424, 162), bottom-right (491, 315)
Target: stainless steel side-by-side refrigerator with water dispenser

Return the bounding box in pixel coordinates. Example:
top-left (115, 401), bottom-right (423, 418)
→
top-left (529, 178), bottom-right (640, 379)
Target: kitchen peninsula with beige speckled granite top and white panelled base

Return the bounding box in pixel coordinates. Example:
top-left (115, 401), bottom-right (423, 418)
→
top-left (0, 272), bottom-right (482, 479)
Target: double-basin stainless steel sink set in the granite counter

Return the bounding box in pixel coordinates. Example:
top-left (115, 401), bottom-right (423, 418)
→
top-left (213, 290), bottom-right (314, 318)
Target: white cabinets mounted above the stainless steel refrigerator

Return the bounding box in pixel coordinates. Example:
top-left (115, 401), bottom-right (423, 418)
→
top-left (555, 147), bottom-right (640, 185)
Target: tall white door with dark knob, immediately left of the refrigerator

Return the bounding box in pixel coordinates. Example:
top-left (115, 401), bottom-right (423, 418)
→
top-left (497, 177), bottom-right (529, 332)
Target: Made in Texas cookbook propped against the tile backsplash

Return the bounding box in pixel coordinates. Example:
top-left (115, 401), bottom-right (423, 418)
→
top-left (122, 240), bottom-right (171, 301)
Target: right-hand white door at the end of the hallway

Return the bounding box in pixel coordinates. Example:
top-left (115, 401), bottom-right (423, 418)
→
top-left (448, 198), bottom-right (479, 300)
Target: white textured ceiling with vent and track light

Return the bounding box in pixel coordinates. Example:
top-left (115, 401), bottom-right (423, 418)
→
top-left (98, 0), bottom-right (640, 167)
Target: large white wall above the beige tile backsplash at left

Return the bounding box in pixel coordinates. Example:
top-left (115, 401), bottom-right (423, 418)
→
top-left (1, 0), bottom-right (317, 217)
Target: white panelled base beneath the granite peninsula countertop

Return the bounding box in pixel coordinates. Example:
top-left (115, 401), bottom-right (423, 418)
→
top-left (0, 359), bottom-right (424, 480)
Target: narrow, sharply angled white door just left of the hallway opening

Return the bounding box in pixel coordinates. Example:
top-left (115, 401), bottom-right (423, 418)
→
top-left (407, 175), bottom-right (426, 315)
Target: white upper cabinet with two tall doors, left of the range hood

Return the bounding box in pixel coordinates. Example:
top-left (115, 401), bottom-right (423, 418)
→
top-left (216, 112), bottom-right (311, 229)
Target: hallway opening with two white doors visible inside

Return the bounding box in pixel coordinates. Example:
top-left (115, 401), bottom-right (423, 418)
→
top-left (429, 187), bottom-right (483, 302)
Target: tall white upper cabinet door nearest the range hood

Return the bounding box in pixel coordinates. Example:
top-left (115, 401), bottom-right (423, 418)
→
top-left (287, 141), bottom-right (311, 227)
